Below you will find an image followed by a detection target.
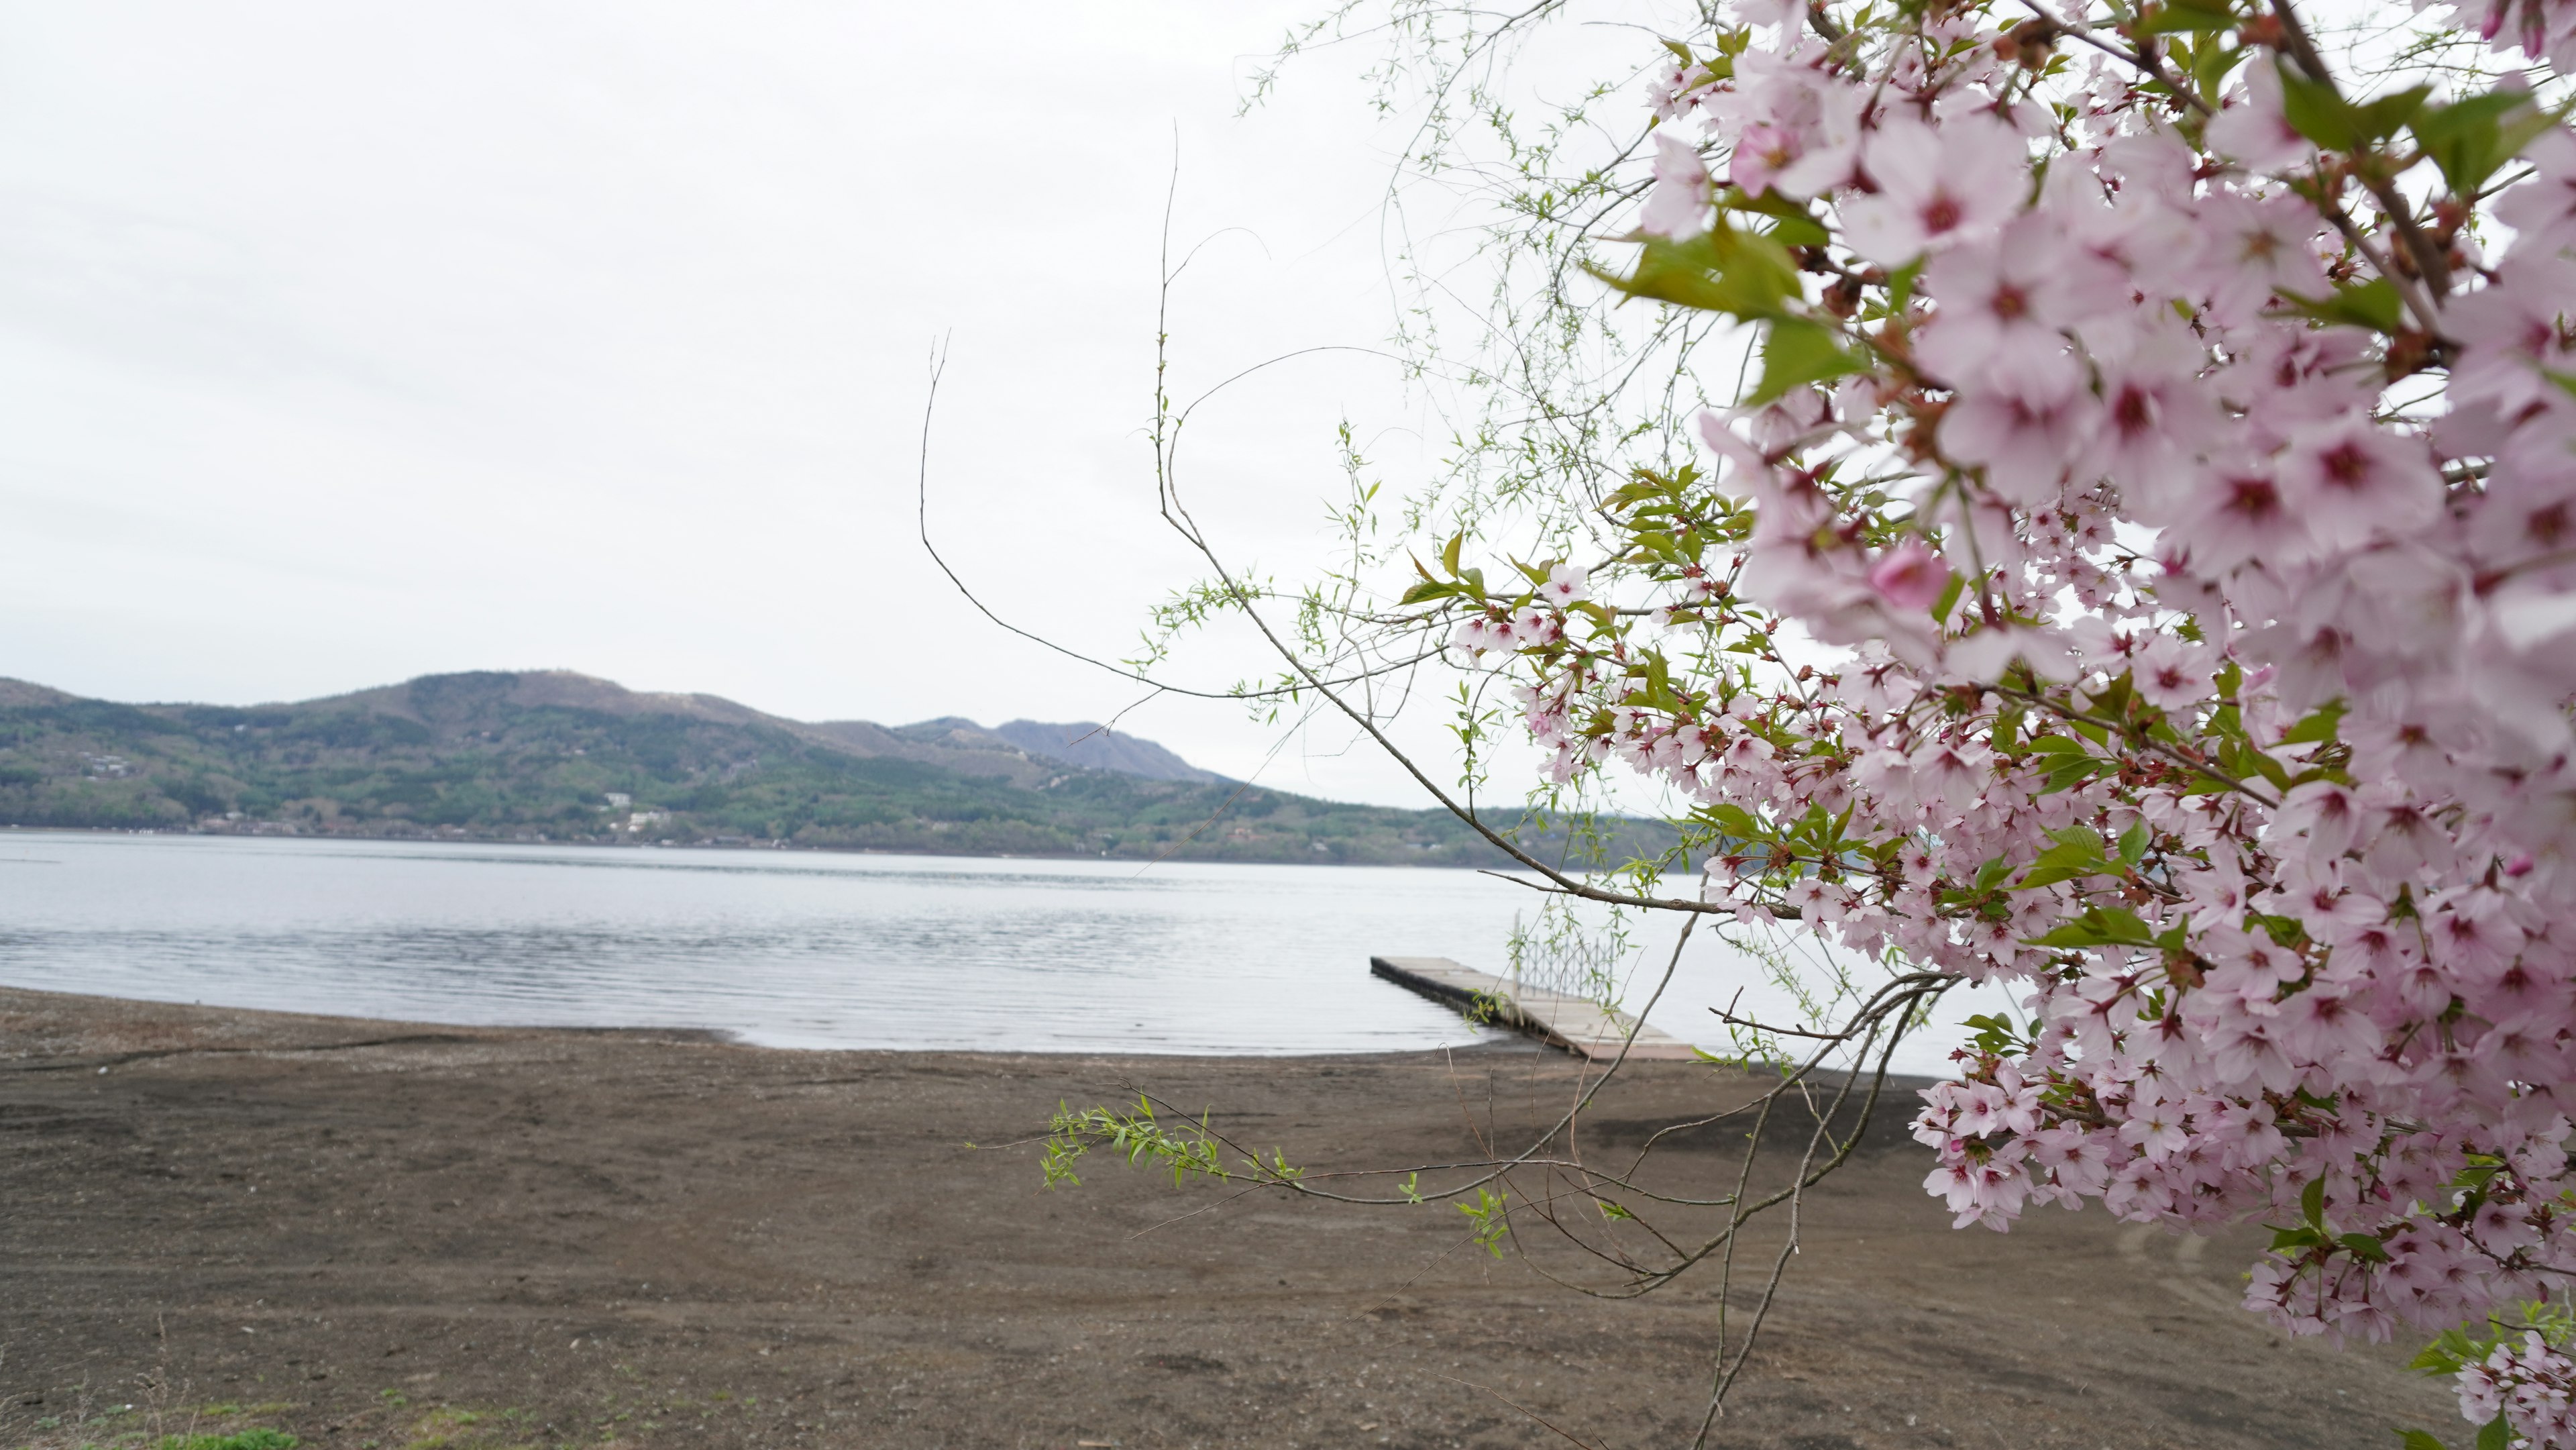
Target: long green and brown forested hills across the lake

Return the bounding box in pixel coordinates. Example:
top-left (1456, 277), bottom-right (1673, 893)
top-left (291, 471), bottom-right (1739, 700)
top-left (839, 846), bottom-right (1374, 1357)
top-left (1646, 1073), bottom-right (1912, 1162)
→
top-left (0, 670), bottom-right (1669, 866)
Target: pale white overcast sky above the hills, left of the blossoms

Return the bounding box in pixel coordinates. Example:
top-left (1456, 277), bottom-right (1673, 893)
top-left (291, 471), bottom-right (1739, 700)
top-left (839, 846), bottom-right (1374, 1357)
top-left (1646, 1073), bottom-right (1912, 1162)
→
top-left (0, 0), bottom-right (1566, 804)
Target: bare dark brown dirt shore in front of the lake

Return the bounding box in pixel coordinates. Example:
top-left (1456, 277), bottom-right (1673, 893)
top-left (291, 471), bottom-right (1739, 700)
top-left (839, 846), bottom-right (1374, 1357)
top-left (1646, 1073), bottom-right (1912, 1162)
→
top-left (0, 989), bottom-right (2460, 1450)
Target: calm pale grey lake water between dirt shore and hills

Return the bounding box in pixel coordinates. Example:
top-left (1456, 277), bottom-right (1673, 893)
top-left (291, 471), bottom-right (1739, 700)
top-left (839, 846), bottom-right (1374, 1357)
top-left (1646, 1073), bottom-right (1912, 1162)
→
top-left (0, 832), bottom-right (1988, 1064)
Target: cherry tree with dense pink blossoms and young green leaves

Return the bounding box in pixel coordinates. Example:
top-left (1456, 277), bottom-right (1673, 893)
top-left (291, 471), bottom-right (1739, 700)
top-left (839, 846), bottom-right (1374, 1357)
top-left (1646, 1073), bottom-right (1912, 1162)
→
top-left (1014, 0), bottom-right (2576, 1447)
